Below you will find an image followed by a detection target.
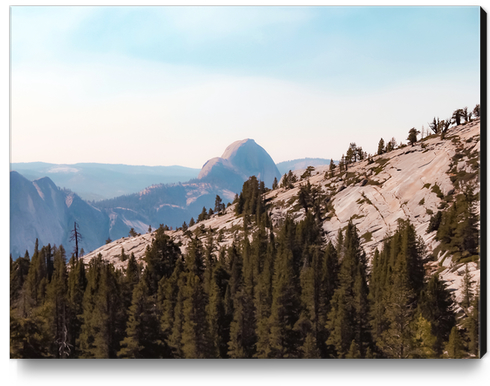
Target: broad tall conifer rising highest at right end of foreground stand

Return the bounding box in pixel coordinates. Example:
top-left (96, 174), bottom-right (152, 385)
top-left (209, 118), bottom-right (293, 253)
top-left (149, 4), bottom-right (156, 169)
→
top-left (369, 220), bottom-right (434, 358)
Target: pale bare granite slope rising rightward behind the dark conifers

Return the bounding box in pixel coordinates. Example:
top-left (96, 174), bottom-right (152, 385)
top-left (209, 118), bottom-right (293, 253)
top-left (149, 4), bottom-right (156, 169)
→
top-left (82, 121), bottom-right (480, 301)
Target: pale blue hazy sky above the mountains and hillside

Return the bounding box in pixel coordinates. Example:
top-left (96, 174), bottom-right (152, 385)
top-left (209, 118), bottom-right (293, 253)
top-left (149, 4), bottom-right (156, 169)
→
top-left (11, 7), bottom-right (480, 168)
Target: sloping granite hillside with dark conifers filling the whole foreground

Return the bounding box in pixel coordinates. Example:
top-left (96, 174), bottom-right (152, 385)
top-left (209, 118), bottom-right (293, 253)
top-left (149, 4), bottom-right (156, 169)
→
top-left (10, 105), bottom-right (482, 358)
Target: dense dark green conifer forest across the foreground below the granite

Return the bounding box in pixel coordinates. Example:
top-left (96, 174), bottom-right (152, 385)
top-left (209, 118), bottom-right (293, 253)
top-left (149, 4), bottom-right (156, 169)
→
top-left (10, 169), bottom-right (479, 358)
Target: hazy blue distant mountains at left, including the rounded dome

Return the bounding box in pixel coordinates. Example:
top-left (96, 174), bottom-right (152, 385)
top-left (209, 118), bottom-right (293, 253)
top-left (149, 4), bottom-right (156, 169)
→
top-left (10, 139), bottom-right (281, 259)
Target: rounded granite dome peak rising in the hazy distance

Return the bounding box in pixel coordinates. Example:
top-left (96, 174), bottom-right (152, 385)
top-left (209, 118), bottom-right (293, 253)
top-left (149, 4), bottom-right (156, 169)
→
top-left (198, 139), bottom-right (281, 190)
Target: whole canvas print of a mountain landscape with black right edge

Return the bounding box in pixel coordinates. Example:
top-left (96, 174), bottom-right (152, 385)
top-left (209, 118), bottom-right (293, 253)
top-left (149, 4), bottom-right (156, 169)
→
top-left (10, 6), bottom-right (486, 359)
